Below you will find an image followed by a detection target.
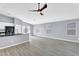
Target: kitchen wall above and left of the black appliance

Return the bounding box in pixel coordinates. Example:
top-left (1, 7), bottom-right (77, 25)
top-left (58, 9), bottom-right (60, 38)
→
top-left (0, 14), bottom-right (14, 32)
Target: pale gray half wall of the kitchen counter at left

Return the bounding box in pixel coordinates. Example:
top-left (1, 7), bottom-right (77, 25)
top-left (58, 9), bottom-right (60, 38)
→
top-left (0, 34), bottom-right (29, 49)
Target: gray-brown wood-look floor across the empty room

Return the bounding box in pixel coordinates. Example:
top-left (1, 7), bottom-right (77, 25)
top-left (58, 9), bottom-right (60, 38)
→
top-left (0, 36), bottom-right (79, 56)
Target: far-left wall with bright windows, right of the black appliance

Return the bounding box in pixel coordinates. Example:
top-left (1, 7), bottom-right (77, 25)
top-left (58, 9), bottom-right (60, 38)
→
top-left (14, 18), bottom-right (32, 34)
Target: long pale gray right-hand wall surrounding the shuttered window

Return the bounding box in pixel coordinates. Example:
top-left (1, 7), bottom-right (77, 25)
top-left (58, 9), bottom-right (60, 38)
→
top-left (34, 19), bottom-right (79, 41)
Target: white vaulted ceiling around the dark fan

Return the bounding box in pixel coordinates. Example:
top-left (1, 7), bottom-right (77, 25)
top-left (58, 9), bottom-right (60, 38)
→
top-left (0, 3), bottom-right (79, 24)
